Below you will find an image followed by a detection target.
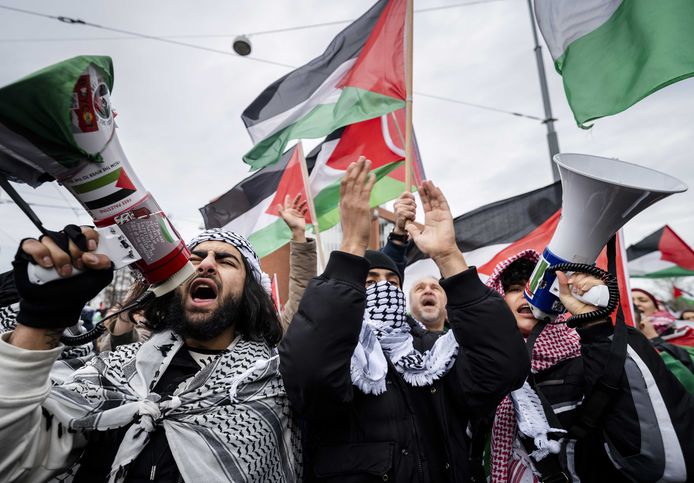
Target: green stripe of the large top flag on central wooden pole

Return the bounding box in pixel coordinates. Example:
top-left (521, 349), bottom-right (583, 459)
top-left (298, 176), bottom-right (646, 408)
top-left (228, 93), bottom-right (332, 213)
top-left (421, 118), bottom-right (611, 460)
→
top-left (243, 87), bottom-right (405, 170)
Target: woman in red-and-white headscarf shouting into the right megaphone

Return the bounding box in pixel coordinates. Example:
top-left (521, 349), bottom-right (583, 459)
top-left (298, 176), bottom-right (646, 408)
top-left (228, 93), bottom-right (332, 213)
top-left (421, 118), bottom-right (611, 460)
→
top-left (482, 250), bottom-right (694, 483)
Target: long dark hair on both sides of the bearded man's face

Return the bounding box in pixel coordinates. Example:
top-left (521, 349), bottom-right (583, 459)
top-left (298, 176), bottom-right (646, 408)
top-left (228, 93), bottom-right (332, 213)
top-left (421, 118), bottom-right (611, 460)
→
top-left (144, 257), bottom-right (282, 346)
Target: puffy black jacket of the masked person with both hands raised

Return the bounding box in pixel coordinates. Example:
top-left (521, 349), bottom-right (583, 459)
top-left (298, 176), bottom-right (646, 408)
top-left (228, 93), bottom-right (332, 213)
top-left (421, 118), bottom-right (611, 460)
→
top-left (279, 252), bottom-right (530, 483)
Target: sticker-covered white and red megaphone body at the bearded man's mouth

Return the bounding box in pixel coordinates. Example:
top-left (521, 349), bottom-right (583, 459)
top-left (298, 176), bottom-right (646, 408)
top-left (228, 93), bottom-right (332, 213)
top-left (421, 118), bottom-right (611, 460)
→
top-left (60, 60), bottom-right (190, 283)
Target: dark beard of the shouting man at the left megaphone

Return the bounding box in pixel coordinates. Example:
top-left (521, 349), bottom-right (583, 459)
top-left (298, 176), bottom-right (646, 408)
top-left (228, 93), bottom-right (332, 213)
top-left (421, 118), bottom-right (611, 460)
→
top-left (167, 291), bottom-right (241, 341)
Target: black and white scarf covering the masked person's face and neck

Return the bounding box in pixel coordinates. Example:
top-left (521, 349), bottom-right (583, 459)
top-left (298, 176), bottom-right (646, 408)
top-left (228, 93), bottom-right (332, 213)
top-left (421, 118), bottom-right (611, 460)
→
top-left (351, 281), bottom-right (458, 394)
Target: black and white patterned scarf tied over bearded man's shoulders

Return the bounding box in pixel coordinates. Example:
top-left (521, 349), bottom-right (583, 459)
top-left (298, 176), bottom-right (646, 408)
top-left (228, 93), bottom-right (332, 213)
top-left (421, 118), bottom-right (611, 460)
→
top-left (44, 330), bottom-right (301, 482)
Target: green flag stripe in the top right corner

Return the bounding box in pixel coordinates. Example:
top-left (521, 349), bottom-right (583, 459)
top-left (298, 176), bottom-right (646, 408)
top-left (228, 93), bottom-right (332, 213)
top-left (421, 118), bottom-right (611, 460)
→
top-left (555, 0), bottom-right (694, 128)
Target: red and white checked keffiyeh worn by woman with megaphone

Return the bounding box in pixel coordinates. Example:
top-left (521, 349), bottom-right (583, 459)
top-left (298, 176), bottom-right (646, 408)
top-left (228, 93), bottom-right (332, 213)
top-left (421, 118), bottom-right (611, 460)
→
top-left (487, 249), bottom-right (581, 483)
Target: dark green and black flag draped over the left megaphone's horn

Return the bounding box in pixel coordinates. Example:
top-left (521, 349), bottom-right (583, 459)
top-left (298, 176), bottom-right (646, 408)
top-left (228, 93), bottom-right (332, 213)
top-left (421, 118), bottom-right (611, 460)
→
top-left (0, 56), bottom-right (113, 187)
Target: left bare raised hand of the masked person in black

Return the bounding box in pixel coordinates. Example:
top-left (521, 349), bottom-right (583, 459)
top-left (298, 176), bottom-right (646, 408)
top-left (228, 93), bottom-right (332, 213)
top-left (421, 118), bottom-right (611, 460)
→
top-left (340, 156), bottom-right (376, 257)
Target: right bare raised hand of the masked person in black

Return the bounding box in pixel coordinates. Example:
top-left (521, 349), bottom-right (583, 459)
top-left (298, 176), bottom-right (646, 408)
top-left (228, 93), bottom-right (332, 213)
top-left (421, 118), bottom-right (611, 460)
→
top-left (405, 181), bottom-right (468, 277)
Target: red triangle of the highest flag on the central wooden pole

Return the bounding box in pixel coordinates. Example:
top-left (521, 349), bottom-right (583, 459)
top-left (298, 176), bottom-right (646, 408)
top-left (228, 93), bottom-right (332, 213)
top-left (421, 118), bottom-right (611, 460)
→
top-left (337, 0), bottom-right (407, 100)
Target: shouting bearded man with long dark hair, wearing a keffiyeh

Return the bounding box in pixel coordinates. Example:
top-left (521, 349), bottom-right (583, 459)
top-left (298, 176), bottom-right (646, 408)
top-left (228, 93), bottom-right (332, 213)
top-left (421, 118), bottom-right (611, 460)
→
top-left (0, 227), bottom-right (300, 482)
